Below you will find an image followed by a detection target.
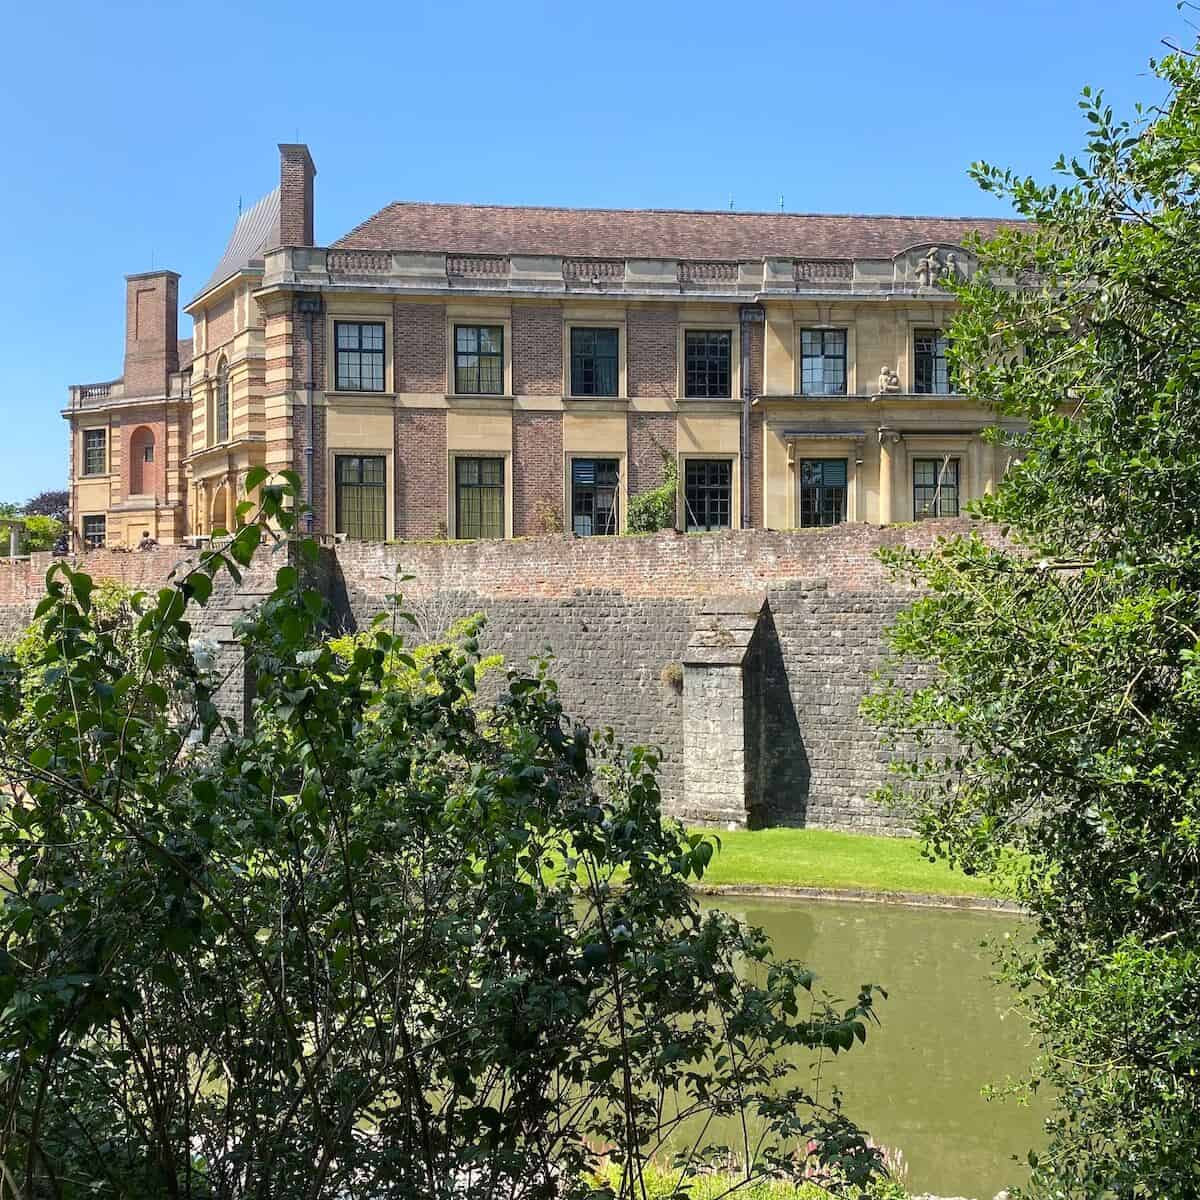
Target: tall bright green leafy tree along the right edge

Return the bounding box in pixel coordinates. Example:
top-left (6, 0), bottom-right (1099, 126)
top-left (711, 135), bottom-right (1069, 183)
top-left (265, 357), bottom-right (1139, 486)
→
top-left (866, 54), bottom-right (1200, 1200)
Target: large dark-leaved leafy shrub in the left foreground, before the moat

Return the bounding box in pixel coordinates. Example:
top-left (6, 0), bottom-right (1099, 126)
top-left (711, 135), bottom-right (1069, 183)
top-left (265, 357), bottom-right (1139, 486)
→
top-left (0, 472), bottom-right (880, 1200)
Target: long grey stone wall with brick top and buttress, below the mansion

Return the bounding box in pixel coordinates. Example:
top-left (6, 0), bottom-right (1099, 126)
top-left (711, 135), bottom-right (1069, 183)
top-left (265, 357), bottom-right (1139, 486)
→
top-left (0, 521), bottom-right (978, 833)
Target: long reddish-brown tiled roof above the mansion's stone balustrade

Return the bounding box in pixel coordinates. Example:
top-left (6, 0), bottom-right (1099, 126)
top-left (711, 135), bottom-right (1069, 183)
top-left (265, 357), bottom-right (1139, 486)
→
top-left (334, 202), bottom-right (1024, 259)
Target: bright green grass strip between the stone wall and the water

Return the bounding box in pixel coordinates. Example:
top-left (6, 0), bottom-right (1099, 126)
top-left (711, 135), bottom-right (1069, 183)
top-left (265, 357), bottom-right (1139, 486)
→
top-left (703, 829), bottom-right (1004, 896)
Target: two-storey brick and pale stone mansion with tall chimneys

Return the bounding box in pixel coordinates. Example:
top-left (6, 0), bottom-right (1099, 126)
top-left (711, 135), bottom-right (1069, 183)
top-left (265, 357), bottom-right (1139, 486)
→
top-left (64, 144), bottom-right (1012, 547)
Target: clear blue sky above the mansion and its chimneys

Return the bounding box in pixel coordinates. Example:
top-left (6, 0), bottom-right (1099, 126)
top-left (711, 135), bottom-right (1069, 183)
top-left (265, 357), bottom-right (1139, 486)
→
top-left (0, 0), bottom-right (1194, 500)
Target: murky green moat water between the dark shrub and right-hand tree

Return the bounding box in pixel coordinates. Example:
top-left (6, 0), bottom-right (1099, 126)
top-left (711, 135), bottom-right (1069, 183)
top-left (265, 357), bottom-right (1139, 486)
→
top-left (709, 896), bottom-right (1042, 1200)
